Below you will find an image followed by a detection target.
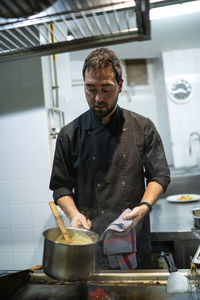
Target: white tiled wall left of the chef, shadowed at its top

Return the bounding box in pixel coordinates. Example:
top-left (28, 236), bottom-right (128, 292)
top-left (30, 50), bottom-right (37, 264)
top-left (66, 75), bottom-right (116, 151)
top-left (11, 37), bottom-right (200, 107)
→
top-left (0, 58), bottom-right (55, 270)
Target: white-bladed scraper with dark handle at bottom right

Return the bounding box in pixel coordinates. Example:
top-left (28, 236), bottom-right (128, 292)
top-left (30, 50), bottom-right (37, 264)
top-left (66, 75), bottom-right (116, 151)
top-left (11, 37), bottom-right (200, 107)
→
top-left (164, 253), bottom-right (190, 293)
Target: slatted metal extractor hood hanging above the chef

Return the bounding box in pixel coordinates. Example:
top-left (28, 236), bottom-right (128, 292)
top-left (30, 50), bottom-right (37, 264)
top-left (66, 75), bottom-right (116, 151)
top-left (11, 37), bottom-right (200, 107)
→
top-left (0, 0), bottom-right (150, 61)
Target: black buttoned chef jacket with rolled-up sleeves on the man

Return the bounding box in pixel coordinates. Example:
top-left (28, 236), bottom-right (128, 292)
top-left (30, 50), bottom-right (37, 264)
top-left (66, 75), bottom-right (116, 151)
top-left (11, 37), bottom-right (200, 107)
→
top-left (50, 106), bottom-right (170, 270)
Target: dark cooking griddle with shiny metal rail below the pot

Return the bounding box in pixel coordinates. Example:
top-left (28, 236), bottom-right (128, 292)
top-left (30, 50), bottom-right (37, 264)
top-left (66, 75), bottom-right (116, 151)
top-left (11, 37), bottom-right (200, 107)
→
top-left (6, 270), bottom-right (199, 300)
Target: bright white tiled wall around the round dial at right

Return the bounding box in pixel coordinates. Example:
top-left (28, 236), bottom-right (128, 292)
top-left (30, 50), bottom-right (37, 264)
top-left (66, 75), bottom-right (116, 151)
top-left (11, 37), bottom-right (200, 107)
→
top-left (163, 49), bottom-right (200, 168)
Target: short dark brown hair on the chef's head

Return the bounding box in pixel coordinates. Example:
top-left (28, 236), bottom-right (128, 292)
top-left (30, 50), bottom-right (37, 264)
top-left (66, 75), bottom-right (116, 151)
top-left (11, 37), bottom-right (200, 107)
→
top-left (82, 48), bottom-right (122, 83)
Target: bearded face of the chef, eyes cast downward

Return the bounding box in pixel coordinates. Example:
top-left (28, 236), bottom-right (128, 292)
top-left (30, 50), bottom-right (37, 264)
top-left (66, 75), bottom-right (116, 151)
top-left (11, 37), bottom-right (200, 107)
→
top-left (84, 66), bottom-right (123, 118)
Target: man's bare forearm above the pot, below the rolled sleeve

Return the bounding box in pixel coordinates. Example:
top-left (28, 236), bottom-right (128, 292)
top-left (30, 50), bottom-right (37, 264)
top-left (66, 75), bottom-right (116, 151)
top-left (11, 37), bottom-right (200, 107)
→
top-left (57, 195), bottom-right (78, 221)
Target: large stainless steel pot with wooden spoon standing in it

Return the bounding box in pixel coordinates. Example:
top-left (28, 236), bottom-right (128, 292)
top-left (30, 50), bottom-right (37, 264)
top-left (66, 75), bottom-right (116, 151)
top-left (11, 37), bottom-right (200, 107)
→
top-left (43, 227), bottom-right (99, 280)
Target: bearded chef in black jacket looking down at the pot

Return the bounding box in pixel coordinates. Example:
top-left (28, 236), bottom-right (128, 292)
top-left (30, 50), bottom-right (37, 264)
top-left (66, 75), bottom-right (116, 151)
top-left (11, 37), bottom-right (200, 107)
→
top-left (50, 48), bottom-right (170, 269)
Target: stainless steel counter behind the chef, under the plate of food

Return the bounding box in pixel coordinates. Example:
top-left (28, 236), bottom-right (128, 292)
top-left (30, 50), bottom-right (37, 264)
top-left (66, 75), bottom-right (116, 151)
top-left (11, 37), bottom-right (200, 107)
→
top-left (150, 198), bottom-right (200, 268)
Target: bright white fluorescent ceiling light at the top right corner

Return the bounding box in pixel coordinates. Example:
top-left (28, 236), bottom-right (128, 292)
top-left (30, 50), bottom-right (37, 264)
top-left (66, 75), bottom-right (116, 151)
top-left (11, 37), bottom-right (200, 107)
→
top-left (150, 1), bottom-right (200, 20)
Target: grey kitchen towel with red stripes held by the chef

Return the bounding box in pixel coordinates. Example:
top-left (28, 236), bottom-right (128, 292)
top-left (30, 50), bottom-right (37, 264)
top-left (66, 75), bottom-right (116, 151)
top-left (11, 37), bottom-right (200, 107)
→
top-left (101, 208), bottom-right (137, 270)
